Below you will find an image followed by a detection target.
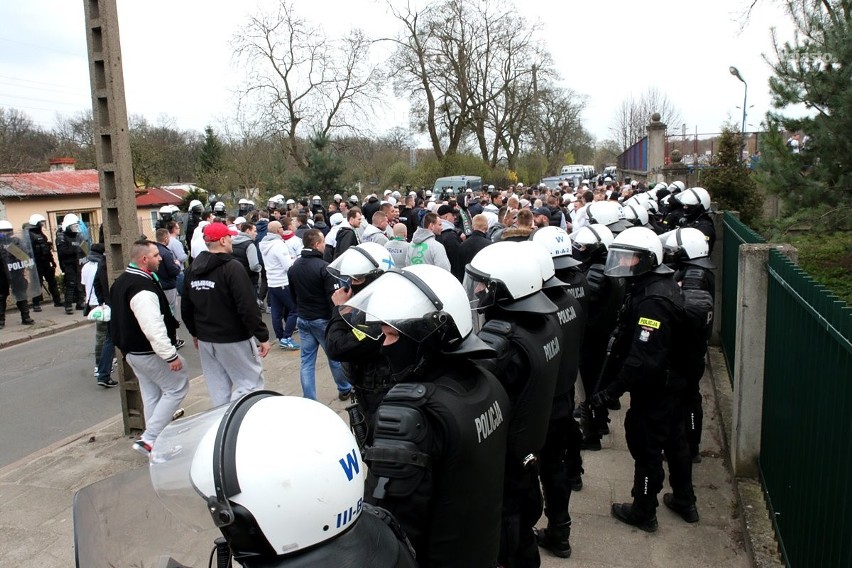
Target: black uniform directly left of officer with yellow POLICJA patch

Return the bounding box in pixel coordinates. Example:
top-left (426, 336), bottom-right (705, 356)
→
top-left (580, 256), bottom-right (625, 449)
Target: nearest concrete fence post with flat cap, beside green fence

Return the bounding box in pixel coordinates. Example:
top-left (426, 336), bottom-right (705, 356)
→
top-left (731, 244), bottom-right (797, 477)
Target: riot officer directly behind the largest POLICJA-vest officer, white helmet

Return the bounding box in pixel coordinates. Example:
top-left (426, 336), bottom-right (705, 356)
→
top-left (465, 241), bottom-right (564, 568)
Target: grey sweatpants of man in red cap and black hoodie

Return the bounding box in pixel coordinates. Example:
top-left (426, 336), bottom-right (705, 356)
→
top-left (198, 339), bottom-right (263, 407)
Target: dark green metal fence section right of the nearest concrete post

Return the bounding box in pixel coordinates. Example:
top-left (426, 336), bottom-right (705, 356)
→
top-left (760, 250), bottom-right (852, 568)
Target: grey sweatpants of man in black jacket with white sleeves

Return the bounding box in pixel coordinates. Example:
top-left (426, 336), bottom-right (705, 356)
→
top-left (127, 354), bottom-right (189, 446)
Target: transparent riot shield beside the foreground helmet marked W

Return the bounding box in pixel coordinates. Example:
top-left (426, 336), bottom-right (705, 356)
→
top-left (73, 467), bottom-right (222, 568)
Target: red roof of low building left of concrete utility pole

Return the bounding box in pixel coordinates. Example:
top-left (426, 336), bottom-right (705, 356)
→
top-left (0, 170), bottom-right (100, 199)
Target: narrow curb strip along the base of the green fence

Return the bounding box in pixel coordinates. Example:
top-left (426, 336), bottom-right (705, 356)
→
top-left (708, 346), bottom-right (786, 568)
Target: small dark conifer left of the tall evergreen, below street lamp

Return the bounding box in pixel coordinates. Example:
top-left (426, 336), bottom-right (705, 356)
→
top-left (701, 125), bottom-right (763, 224)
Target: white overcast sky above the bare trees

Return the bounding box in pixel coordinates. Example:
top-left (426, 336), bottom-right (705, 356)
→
top-left (0, 0), bottom-right (791, 144)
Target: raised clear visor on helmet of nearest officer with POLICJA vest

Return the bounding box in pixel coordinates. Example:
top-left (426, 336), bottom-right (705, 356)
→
top-left (340, 272), bottom-right (447, 343)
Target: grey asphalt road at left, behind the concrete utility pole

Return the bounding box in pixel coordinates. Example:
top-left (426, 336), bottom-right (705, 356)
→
top-left (0, 325), bottom-right (201, 467)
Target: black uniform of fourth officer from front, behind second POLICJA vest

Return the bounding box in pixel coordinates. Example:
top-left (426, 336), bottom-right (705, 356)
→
top-left (539, 282), bottom-right (586, 554)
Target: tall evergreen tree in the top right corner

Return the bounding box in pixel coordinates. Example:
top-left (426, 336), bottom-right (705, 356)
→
top-left (759, 0), bottom-right (852, 214)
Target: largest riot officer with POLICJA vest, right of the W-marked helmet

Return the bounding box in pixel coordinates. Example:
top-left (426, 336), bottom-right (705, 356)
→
top-left (344, 264), bottom-right (510, 568)
